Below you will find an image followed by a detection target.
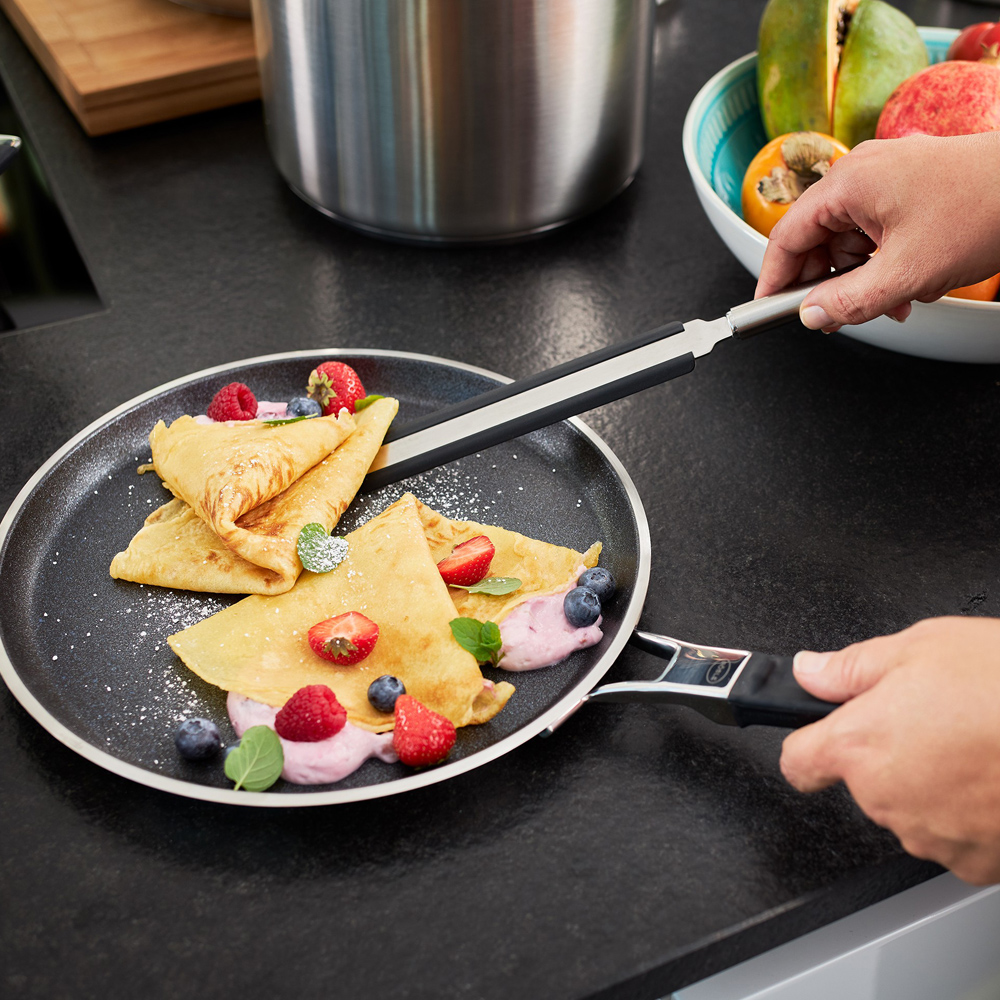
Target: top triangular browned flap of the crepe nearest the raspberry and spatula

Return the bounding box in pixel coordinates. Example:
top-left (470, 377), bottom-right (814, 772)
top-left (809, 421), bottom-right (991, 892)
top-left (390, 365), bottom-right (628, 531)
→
top-left (149, 410), bottom-right (354, 572)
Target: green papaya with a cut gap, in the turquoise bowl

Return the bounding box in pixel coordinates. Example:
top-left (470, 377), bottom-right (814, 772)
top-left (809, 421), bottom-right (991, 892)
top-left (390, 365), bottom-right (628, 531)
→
top-left (757, 0), bottom-right (927, 147)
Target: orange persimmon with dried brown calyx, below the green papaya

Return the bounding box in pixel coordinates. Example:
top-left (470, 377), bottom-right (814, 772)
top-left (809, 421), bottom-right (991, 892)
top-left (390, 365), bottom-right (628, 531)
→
top-left (740, 132), bottom-right (849, 236)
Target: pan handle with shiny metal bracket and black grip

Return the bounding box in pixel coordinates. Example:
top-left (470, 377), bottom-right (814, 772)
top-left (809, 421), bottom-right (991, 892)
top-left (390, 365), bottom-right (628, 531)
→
top-left (547, 630), bottom-right (837, 733)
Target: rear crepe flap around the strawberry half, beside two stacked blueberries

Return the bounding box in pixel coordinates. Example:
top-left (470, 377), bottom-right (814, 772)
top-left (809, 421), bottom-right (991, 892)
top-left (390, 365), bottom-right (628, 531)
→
top-left (417, 500), bottom-right (601, 624)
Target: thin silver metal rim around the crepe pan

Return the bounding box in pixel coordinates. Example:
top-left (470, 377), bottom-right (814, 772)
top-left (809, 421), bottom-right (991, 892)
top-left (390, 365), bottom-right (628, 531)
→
top-left (0, 347), bottom-right (651, 808)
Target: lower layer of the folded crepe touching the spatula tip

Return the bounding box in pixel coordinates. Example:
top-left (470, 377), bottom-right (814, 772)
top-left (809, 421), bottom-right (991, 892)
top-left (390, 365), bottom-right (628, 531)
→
top-left (111, 398), bottom-right (399, 594)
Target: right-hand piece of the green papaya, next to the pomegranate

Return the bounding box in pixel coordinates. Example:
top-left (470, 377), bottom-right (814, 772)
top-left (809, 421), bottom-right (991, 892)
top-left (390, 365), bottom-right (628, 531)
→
top-left (833, 0), bottom-right (927, 148)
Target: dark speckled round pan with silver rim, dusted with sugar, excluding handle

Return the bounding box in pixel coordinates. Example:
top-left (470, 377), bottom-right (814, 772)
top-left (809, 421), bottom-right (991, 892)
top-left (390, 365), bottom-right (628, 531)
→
top-left (0, 350), bottom-right (649, 806)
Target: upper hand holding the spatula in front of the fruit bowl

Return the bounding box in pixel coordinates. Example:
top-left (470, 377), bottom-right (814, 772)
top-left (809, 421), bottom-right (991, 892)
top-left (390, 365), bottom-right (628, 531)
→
top-left (756, 132), bottom-right (1000, 333)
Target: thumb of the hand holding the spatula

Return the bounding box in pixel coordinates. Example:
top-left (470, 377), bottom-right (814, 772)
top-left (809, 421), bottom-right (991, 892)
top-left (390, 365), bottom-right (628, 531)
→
top-left (799, 248), bottom-right (914, 333)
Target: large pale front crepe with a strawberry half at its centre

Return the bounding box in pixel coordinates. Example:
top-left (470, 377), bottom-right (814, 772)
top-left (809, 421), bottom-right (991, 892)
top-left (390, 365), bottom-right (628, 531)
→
top-left (168, 493), bottom-right (514, 732)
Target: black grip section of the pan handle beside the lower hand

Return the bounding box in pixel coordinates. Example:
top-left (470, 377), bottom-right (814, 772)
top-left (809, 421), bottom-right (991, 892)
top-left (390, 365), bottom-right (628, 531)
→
top-left (727, 653), bottom-right (837, 729)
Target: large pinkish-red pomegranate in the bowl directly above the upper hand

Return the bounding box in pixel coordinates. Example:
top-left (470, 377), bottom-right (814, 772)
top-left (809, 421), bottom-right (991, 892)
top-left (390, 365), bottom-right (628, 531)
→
top-left (875, 61), bottom-right (1000, 139)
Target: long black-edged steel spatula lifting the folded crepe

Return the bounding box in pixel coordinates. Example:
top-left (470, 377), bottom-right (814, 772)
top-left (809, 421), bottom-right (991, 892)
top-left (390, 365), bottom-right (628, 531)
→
top-left (363, 274), bottom-right (832, 491)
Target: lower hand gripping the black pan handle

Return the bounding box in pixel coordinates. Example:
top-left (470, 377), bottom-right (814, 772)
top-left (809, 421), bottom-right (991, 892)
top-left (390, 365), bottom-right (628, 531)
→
top-left (781, 617), bottom-right (1000, 885)
